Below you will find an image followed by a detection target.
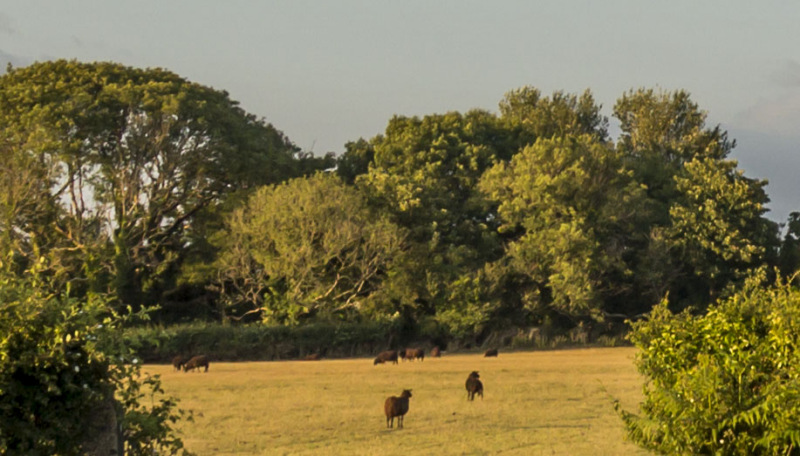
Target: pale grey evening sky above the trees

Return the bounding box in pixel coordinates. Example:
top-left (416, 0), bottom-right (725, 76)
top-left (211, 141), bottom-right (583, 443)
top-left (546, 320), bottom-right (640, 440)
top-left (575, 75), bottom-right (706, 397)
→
top-left (0, 0), bottom-right (800, 222)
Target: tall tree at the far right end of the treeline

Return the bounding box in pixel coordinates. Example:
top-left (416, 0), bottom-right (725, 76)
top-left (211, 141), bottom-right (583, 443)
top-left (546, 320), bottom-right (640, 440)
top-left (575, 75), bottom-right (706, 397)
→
top-left (614, 89), bottom-right (776, 313)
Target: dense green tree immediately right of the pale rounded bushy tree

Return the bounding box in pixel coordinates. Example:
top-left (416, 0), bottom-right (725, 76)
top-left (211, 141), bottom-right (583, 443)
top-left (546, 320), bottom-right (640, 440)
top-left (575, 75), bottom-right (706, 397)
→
top-left (356, 111), bottom-right (505, 314)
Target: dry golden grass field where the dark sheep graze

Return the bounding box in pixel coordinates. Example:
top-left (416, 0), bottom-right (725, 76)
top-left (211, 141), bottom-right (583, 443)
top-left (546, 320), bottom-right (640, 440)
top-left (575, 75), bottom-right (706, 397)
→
top-left (146, 348), bottom-right (645, 456)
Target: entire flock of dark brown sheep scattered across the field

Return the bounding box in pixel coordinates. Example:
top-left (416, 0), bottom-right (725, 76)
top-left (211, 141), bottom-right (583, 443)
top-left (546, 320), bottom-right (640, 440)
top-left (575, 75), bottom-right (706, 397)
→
top-left (172, 347), bottom-right (497, 429)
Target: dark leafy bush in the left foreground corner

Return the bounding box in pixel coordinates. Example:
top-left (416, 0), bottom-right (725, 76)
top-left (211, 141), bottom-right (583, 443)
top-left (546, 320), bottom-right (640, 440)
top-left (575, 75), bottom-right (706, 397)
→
top-left (0, 263), bottom-right (189, 455)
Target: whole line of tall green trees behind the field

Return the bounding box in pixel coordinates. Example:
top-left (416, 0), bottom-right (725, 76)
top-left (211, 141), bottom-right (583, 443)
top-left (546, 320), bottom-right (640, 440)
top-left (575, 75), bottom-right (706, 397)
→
top-left (0, 61), bottom-right (800, 339)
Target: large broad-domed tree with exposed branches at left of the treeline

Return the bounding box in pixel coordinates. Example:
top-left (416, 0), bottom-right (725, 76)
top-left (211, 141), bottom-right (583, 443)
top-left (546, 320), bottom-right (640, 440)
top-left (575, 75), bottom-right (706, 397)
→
top-left (0, 60), bottom-right (310, 305)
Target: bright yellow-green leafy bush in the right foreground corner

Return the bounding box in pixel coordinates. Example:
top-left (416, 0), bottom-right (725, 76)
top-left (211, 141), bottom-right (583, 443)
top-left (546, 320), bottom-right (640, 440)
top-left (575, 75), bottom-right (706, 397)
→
top-left (619, 274), bottom-right (800, 455)
